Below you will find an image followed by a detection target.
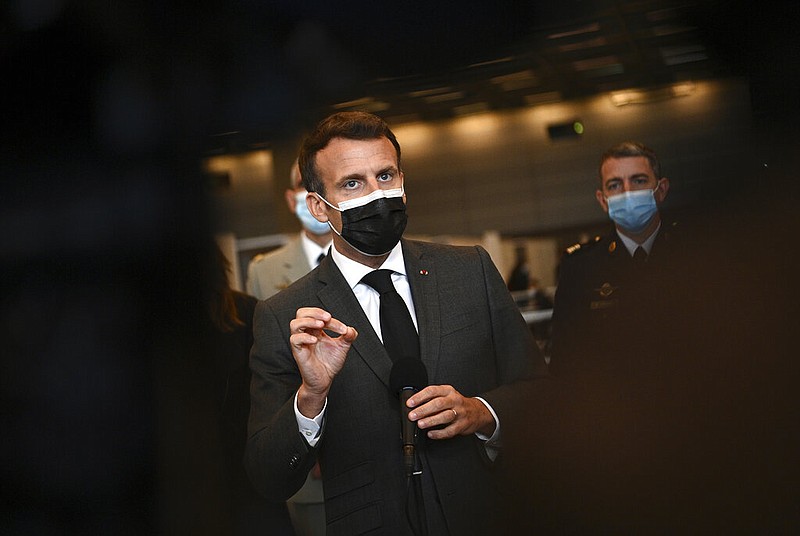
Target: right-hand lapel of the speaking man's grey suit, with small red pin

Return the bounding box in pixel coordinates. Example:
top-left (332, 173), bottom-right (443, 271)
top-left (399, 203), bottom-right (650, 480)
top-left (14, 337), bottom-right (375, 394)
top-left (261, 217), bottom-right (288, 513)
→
top-left (403, 240), bottom-right (441, 383)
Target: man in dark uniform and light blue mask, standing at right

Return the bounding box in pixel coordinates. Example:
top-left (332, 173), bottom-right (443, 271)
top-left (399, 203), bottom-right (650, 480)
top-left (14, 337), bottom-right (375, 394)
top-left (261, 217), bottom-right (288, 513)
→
top-left (551, 142), bottom-right (675, 377)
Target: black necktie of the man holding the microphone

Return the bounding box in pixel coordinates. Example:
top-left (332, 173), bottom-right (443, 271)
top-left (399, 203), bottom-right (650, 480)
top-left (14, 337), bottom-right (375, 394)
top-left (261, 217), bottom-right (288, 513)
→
top-left (361, 270), bottom-right (419, 361)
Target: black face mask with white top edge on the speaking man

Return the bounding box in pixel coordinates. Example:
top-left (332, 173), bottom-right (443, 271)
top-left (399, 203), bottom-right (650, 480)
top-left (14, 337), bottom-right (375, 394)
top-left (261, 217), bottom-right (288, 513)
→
top-left (320, 192), bottom-right (408, 257)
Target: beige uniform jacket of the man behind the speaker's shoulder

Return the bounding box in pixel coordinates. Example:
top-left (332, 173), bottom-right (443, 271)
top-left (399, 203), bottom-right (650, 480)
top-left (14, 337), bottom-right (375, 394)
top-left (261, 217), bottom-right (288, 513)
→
top-left (246, 235), bottom-right (311, 300)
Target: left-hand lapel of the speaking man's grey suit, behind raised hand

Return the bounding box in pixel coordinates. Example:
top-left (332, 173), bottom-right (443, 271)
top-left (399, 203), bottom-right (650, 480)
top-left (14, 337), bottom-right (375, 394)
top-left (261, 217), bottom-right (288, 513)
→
top-left (317, 255), bottom-right (392, 386)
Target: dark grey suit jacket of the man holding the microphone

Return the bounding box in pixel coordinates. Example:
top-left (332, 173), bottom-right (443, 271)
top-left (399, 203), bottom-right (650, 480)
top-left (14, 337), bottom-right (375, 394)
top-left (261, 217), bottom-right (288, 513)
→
top-left (246, 240), bottom-right (545, 535)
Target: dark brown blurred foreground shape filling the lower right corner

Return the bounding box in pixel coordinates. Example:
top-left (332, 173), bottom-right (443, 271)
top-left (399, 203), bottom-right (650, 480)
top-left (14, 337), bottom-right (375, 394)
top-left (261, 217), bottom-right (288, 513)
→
top-left (504, 169), bottom-right (800, 534)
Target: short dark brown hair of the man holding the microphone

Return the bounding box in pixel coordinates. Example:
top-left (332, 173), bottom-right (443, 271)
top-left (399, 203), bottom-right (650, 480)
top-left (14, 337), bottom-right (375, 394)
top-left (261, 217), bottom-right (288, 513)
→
top-left (299, 112), bottom-right (400, 196)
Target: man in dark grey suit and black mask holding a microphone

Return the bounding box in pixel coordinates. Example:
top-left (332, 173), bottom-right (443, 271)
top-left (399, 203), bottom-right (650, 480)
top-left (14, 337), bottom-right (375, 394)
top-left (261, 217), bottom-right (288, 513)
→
top-left (246, 112), bottom-right (544, 535)
